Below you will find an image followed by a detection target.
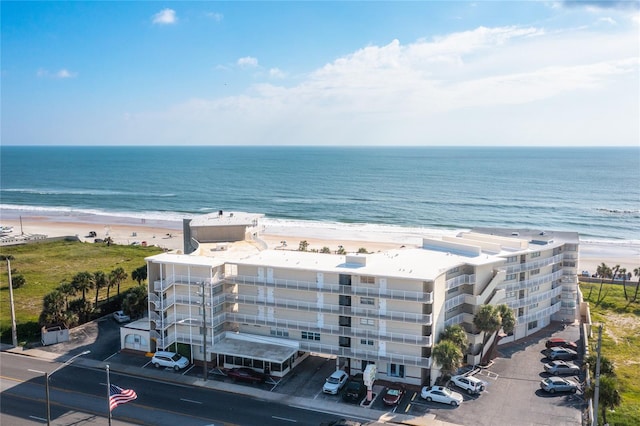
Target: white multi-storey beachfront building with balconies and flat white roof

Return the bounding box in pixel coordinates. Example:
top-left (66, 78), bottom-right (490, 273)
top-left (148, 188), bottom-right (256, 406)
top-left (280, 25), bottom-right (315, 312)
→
top-left (146, 212), bottom-right (578, 385)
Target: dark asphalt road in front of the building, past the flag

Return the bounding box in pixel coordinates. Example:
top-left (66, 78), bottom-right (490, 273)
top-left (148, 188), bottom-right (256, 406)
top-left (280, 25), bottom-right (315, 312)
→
top-left (0, 353), bottom-right (348, 426)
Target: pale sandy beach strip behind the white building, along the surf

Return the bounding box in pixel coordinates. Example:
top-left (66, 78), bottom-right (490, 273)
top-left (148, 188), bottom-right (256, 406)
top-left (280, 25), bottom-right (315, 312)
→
top-left (2, 216), bottom-right (640, 274)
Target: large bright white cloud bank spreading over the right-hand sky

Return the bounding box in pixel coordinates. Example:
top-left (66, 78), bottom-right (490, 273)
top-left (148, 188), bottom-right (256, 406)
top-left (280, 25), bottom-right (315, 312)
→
top-left (121, 27), bottom-right (640, 146)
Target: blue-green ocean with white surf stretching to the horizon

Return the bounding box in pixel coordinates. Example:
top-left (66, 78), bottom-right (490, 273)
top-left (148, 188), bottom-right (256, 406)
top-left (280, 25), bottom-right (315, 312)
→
top-left (0, 146), bottom-right (640, 243)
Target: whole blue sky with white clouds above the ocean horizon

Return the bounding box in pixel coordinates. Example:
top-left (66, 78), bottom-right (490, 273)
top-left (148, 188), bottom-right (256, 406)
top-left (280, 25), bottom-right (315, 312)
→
top-left (0, 1), bottom-right (640, 146)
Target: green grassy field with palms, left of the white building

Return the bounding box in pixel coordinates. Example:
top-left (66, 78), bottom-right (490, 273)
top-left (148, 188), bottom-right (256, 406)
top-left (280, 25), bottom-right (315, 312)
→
top-left (0, 241), bottom-right (162, 342)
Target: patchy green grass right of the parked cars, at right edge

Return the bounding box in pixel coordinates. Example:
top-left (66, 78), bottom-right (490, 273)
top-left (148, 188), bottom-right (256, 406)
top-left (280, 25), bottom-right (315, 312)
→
top-left (580, 282), bottom-right (640, 426)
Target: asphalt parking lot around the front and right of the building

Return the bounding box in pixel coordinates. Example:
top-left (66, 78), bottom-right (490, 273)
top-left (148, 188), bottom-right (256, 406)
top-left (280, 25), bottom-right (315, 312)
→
top-left (33, 318), bottom-right (583, 425)
